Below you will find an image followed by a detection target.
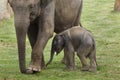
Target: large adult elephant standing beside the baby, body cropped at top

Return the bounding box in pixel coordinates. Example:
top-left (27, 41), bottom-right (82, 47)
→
top-left (8, 0), bottom-right (82, 73)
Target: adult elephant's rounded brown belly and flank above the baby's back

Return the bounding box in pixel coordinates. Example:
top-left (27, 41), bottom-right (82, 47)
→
top-left (54, 0), bottom-right (81, 33)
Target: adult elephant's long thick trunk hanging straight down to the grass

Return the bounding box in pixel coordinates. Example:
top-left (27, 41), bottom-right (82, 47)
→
top-left (15, 20), bottom-right (28, 73)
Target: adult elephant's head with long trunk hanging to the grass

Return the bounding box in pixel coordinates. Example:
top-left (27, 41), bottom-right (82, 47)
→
top-left (8, 0), bottom-right (41, 73)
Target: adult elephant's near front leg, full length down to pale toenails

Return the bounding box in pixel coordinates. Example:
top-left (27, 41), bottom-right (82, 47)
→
top-left (28, 0), bottom-right (55, 73)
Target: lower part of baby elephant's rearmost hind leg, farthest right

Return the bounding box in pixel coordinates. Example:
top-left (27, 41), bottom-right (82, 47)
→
top-left (89, 50), bottom-right (97, 72)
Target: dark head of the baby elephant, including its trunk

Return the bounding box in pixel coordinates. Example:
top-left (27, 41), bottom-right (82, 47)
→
top-left (46, 35), bottom-right (65, 66)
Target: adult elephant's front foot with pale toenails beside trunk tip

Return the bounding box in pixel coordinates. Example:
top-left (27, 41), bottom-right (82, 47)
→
top-left (26, 65), bottom-right (41, 74)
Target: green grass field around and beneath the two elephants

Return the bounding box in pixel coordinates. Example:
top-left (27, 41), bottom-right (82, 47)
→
top-left (0, 0), bottom-right (120, 80)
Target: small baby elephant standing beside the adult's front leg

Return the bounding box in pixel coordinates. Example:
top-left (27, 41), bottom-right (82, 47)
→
top-left (46, 26), bottom-right (97, 72)
